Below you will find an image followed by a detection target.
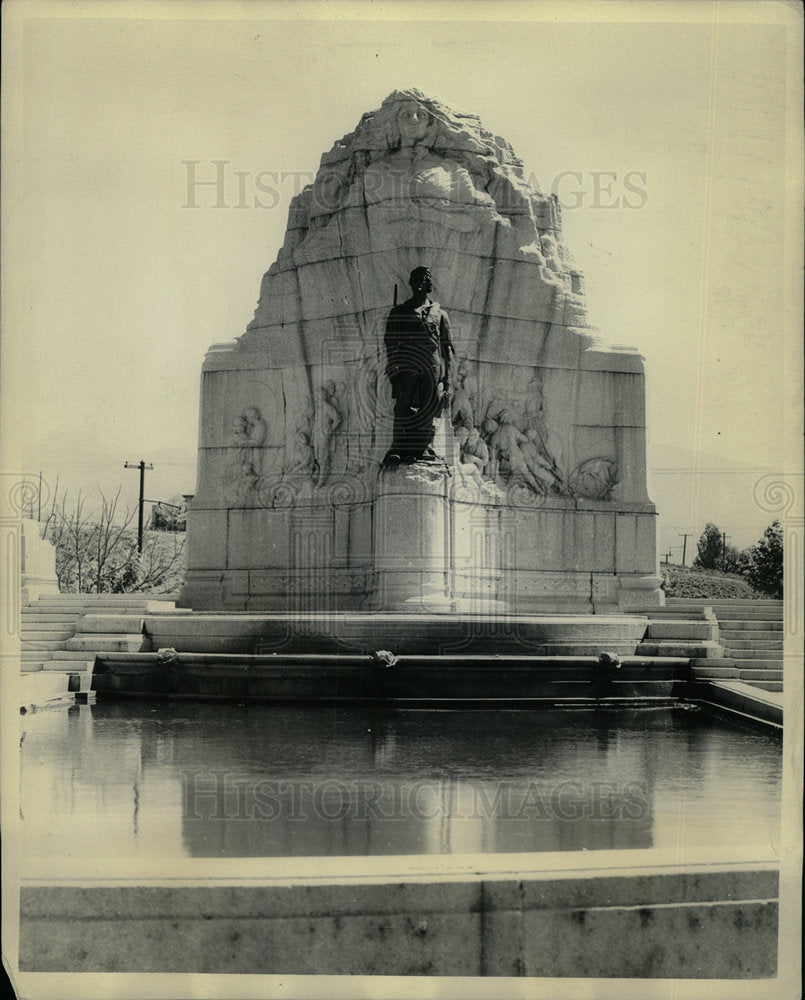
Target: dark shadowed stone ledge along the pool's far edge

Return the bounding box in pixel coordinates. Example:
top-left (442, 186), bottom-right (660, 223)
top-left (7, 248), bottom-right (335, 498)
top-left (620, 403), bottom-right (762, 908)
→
top-left (93, 652), bottom-right (691, 706)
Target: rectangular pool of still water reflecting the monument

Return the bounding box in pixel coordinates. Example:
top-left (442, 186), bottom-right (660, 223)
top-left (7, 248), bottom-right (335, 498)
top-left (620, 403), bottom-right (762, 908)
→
top-left (21, 702), bottom-right (780, 859)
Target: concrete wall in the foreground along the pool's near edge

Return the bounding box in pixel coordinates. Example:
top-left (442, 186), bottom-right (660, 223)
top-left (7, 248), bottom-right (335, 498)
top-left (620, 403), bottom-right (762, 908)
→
top-left (20, 851), bottom-right (778, 979)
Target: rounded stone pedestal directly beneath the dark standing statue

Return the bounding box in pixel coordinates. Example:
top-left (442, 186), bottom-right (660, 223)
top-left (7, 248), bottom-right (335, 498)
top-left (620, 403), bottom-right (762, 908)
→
top-left (367, 462), bottom-right (458, 614)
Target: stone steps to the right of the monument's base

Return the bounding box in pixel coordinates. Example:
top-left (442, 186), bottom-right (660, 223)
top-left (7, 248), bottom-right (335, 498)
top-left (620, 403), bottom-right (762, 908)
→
top-left (662, 597), bottom-right (783, 692)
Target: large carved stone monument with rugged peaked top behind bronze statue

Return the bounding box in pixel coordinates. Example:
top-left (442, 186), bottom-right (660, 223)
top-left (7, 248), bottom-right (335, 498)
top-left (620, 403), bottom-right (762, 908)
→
top-left (181, 89), bottom-right (663, 614)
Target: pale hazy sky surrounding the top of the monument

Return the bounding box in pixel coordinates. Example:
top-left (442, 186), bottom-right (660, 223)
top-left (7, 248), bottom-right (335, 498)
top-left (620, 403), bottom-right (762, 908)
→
top-left (0, 0), bottom-right (802, 562)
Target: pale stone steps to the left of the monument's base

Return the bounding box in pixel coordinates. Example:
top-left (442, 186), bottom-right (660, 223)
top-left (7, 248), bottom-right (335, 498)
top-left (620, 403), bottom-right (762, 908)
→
top-left (20, 594), bottom-right (175, 692)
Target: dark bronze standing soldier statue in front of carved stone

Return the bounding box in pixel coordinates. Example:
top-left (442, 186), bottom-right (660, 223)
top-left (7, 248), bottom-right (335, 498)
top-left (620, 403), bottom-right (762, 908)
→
top-left (385, 267), bottom-right (455, 465)
